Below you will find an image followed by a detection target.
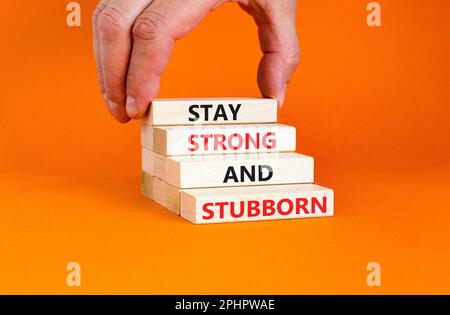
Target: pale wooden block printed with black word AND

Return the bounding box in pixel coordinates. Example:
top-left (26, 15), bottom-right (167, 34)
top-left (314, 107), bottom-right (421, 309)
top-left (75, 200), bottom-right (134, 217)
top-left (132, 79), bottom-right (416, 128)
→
top-left (163, 149), bottom-right (314, 188)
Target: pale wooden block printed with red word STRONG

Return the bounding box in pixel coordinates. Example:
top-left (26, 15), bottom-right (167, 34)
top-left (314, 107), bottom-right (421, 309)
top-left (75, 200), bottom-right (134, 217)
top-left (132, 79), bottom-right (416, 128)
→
top-left (142, 124), bottom-right (296, 156)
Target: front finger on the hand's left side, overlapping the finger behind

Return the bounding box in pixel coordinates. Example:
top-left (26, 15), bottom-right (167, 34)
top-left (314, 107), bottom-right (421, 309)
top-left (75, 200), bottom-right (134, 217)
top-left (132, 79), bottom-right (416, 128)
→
top-left (126, 0), bottom-right (223, 119)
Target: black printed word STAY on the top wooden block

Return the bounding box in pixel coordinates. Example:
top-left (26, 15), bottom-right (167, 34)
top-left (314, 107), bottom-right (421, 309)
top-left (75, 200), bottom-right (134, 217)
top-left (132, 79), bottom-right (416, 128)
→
top-left (189, 104), bottom-right (241, 122)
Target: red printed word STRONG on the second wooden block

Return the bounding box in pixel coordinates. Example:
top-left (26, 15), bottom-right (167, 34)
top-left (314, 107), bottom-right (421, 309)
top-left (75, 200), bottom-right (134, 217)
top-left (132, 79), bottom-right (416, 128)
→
top-left (188, 132), bottom-right (277, 152)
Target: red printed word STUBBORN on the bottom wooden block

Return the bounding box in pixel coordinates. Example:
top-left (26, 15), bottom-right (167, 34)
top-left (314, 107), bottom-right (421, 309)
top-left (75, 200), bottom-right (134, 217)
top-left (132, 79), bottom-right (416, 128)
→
top-left (202, 197), bottom-right (327, 220)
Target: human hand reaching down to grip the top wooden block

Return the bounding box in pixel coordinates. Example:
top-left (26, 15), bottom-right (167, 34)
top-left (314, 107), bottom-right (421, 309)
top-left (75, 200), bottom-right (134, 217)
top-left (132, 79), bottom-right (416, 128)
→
top-left (93, 0), bottom-right (300, 123)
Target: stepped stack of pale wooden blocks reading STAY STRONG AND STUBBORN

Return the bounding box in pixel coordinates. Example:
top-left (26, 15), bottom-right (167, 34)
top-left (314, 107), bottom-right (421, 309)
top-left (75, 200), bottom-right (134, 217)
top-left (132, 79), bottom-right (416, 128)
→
top-left (141, 98), bottom-right (333, 223)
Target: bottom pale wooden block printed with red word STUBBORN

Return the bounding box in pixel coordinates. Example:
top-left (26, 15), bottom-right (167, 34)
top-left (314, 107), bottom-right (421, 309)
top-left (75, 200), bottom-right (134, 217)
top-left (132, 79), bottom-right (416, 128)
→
top-left (180, 184), bottom-right (334, 224)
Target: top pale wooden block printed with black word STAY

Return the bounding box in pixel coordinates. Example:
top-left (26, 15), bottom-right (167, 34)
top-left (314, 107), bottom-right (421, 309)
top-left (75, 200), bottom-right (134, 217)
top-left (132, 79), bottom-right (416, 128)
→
top-left (142, 98), bottom-right (277, 126)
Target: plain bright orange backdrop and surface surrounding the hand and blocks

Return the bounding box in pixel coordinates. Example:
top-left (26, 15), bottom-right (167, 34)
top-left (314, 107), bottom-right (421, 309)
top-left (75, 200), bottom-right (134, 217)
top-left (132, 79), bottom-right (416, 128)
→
top-left (0, 0), bottom-right (450, 294)
